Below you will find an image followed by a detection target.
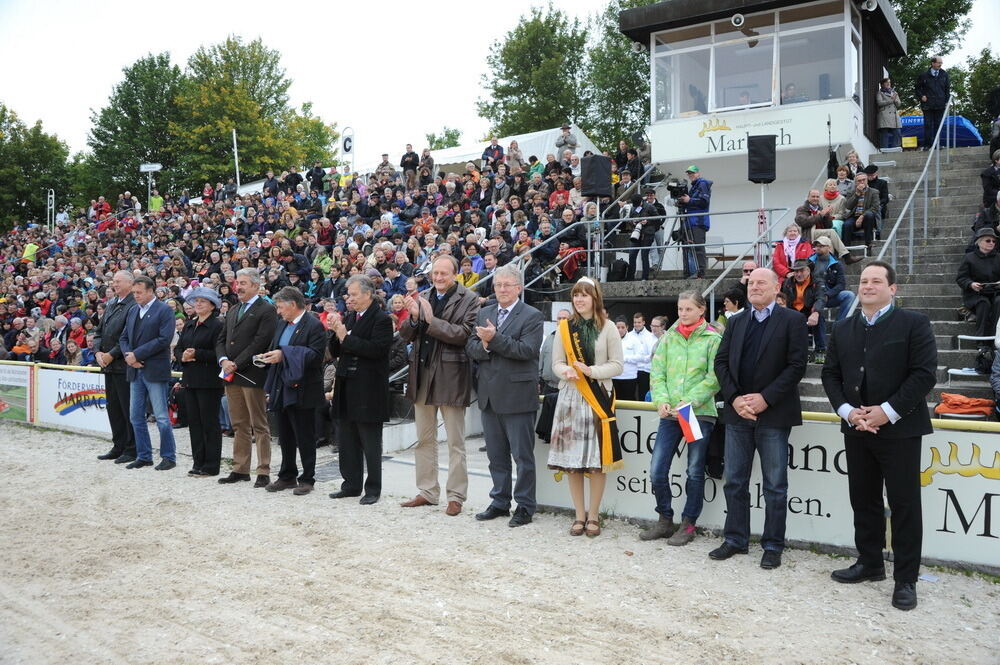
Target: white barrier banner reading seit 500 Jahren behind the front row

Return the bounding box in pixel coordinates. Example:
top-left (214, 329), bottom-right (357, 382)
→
top-left (535, 409), bottom-right (1000, 566)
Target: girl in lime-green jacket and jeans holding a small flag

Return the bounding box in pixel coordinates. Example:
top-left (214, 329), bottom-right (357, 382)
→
top-left (639, 291), bottom-right (722, 546)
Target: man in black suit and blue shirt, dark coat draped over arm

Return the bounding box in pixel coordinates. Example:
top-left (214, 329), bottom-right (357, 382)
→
top-left (256, 286), bottom-right (326, 496)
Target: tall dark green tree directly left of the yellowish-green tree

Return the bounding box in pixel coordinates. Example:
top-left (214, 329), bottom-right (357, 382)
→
top-left (87, 53), bottom-right (184, 200)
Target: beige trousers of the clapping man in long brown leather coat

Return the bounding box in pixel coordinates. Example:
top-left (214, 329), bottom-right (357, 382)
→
top-left (413, 376), bottom-right (469, 503)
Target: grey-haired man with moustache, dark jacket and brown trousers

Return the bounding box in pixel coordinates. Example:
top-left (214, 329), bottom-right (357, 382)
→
top-left (215, 268), bottom-right (278, 487)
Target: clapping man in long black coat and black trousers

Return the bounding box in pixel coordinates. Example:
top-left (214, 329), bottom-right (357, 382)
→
top-left (330, 275), bottom-right (393, 505)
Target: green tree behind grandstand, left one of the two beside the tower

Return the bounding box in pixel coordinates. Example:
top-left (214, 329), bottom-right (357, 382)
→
top-left (478, 4), bottom-right (590, 136)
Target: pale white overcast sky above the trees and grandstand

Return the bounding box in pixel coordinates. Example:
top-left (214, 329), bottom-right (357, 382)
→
top-left (0, 0), bottom-right (1000, 169)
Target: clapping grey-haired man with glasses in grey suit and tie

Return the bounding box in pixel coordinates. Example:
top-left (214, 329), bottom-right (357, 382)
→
top-left (465, 265), bottom-right (543, 527)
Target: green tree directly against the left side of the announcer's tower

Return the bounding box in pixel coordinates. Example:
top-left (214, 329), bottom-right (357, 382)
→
top-left (581, 0), bottom-right (656, 153)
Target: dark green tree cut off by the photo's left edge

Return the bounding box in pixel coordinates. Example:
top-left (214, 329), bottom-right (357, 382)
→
top-left (0, 103), bottom-right (70, 229)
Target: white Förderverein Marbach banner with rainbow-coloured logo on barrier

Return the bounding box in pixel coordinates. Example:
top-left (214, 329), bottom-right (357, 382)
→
top-left (35, 368), bottom-right (111, 434)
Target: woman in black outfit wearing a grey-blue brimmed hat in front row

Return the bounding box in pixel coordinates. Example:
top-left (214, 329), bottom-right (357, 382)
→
top-left (174, 286), bottom-right (223, 477)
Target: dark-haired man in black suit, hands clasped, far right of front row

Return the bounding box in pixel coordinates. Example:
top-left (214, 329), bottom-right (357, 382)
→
top-left (823, 261), bottom-right (937, 610)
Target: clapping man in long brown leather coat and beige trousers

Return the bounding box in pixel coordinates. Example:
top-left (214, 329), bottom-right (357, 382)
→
top-left (400, 255), bottom-right (479, 516)
